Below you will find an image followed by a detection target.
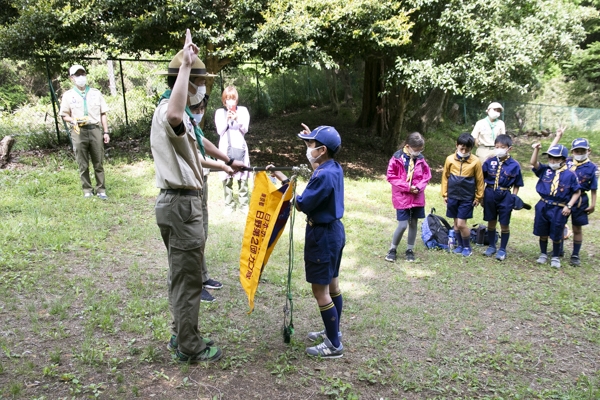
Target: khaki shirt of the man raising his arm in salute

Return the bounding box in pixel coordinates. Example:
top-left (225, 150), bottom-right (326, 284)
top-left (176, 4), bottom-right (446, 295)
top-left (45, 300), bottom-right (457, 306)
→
top-left (150, 99), bottom-right (203, 190)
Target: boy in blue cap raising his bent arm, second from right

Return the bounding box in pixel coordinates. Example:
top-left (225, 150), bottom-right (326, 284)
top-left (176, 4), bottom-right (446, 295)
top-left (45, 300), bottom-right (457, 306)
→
top-left (530, 143), bottom-right (581, 268)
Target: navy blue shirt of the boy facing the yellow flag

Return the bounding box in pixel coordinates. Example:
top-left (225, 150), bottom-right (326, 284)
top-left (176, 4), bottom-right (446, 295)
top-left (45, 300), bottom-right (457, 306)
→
top-left (296, 160), bottom-right (344, 224)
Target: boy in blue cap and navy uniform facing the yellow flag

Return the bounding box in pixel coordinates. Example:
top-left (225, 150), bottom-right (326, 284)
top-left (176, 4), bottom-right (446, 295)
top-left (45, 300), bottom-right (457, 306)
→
top-left (272, 124), bottom-right (346, 358)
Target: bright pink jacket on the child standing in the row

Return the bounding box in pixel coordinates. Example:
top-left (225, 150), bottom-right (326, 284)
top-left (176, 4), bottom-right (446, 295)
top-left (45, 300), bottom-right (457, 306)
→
top-left (387, 150), bottom-right (431, 210)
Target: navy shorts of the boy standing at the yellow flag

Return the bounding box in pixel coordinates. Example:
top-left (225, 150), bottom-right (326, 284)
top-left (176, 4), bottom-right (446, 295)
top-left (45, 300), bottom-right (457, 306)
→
top-left (304, 220), bottom-right (346, 285)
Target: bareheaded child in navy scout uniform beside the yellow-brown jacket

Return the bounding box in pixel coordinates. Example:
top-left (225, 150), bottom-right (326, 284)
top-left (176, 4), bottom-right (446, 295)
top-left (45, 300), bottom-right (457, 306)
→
top-left (483, 135), bottom-right (523, 261)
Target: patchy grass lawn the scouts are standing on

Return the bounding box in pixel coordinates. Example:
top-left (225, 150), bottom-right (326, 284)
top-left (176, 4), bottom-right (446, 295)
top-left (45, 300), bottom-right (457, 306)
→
top-left (0, 111), bottom-right (600, 399)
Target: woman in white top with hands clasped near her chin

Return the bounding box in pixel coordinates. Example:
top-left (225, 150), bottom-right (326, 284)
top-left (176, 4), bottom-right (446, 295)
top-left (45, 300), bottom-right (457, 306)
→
top-left (215, 86), bottom-right (250, 214)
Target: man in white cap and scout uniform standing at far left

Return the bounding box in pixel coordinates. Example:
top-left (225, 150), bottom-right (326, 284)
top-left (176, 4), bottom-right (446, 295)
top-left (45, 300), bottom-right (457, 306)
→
top-left (60, 64), bottom-right (110, 200)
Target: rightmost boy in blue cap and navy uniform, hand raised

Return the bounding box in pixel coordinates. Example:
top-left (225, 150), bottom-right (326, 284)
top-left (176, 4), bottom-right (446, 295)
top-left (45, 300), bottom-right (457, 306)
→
top-left (552, 127), bottom-right (598, 267)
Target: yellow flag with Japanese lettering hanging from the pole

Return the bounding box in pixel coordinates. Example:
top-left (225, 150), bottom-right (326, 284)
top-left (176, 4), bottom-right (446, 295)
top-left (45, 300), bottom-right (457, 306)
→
top-left (240, 172), bottom-right (295, 312)
